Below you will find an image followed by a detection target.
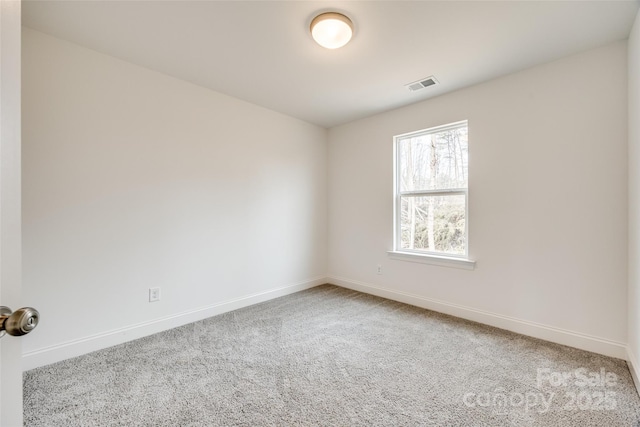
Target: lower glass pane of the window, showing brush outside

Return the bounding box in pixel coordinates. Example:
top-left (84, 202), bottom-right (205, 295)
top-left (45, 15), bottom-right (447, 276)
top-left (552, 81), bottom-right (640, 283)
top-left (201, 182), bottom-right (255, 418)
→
top-left (400, 195), bottom-right (466, 255)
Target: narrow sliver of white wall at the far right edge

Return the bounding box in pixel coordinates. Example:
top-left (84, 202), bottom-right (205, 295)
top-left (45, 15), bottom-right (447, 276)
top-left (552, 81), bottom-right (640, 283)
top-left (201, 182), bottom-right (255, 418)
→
top-left (628, 12), bottom-right (640, 390)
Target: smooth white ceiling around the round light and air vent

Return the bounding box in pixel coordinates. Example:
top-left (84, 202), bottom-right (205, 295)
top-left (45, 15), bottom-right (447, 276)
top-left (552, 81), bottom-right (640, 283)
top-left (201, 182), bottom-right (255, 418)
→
top-left (22, 0), bottom-right (639, 127)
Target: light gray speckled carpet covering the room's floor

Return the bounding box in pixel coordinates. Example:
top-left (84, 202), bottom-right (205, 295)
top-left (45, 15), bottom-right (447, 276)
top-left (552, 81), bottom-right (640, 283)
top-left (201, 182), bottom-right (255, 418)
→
top-left (24, 285), bottom-right (640, 427)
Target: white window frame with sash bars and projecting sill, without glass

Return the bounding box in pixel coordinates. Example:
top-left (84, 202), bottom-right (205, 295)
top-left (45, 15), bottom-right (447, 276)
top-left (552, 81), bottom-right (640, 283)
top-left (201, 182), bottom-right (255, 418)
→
top-left (388, 120), bottom-right (475, 270)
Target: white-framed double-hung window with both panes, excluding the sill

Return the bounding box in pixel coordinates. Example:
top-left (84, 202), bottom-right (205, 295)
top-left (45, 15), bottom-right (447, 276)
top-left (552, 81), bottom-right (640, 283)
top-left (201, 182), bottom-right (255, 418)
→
top-left (394, 121), bottom-right (469, 259)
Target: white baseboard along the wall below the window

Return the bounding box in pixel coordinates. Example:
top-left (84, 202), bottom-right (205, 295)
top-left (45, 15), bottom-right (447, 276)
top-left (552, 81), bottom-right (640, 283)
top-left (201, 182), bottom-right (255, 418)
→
top-left (327, 277), bottom-right (637, 366)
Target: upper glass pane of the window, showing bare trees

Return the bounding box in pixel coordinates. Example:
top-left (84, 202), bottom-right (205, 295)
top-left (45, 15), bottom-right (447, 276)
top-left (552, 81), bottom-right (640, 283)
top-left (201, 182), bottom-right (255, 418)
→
top-left (398, 126), bottom-right (469, 191)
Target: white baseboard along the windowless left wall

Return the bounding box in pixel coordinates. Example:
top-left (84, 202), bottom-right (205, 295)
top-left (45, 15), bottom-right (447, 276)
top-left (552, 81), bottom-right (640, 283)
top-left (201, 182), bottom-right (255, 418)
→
top-left (22, 277), bottom-right (327, 371)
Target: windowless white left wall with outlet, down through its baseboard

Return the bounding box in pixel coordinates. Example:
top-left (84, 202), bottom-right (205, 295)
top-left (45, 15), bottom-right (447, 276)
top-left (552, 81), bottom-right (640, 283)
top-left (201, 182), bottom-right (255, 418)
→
top-left (22, 29), bottom-right (327, 368)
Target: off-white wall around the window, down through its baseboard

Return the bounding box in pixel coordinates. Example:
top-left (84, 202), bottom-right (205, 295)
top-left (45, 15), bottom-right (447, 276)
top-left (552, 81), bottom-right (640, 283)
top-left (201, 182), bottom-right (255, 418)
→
top-left (329, 41), bottom-right (627, 357)
